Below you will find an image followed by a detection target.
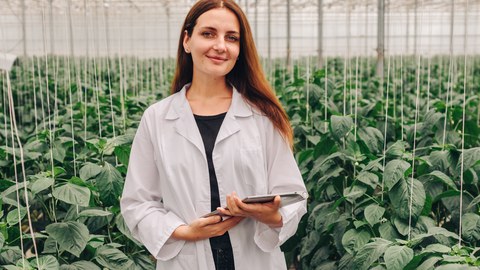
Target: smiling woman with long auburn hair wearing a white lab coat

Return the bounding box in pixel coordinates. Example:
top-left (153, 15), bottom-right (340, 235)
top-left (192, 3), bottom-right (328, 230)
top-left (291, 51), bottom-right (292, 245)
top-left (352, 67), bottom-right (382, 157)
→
top-left (121, 0), bottom-right (306, 270)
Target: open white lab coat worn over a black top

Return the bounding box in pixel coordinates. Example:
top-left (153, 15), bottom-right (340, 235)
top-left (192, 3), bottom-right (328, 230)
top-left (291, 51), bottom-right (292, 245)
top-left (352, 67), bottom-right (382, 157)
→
top-left (121, 85), bottom-right (306, 270)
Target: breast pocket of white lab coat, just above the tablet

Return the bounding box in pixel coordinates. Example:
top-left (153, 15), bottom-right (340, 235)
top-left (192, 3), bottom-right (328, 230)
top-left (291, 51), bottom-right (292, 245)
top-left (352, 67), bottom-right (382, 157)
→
top-left (240, 148), bottom-right (267, 192)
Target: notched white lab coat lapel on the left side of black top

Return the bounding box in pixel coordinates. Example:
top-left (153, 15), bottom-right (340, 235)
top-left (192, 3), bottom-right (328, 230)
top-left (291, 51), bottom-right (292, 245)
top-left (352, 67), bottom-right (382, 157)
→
top-left (166, 85), bottom-right (205, 157)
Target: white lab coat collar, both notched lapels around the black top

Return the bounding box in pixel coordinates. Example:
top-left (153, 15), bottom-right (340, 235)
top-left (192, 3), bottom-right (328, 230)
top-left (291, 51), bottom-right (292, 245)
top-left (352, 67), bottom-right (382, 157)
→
top-left (165, 84), bottom-right (253, 154)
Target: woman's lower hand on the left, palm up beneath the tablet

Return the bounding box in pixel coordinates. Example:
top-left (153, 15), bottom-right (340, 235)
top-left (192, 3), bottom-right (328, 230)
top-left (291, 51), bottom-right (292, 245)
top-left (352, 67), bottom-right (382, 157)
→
top-left (172, 216), bottom-right (244, 241)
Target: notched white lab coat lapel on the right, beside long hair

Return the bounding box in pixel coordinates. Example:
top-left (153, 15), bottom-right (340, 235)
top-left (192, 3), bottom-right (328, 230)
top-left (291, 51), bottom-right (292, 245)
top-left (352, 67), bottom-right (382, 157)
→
top-left (215, 87), bottom-right (252, 144)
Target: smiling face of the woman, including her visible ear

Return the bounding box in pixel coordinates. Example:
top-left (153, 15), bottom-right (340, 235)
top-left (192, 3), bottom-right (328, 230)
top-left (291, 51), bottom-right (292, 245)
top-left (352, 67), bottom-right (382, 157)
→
top-left (183, 8), bottom-right (240, 80)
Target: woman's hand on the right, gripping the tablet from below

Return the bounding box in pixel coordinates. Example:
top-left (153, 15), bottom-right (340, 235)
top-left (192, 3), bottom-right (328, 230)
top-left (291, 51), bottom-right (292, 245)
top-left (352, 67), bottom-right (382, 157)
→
top-left (217, 192), bottom-right (283, 228)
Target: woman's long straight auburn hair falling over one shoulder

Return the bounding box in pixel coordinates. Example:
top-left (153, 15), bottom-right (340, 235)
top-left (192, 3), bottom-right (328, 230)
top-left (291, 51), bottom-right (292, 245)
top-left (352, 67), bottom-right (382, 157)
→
top-left (172, 0), bottom-right (293, 147)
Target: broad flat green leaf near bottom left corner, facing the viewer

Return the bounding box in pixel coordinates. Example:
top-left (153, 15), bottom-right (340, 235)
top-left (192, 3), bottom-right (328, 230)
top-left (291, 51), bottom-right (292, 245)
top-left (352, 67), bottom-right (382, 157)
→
top-left (46, 221), bottom-right (89, 257)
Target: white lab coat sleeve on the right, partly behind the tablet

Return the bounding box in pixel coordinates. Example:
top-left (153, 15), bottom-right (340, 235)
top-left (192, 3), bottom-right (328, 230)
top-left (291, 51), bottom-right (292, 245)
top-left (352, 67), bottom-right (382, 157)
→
top-left (254, 117), bottom-right (307, 252)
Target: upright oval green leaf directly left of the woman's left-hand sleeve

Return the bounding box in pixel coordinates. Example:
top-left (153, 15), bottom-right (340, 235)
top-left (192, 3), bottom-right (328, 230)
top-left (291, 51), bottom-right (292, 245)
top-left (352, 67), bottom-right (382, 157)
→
top-left (97, 162), bottom-right (123, 206)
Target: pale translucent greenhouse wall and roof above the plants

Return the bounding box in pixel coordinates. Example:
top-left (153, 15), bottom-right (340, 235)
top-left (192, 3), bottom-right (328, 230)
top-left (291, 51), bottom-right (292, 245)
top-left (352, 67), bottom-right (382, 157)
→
top-left (0, 0), bottom-right (480, 59)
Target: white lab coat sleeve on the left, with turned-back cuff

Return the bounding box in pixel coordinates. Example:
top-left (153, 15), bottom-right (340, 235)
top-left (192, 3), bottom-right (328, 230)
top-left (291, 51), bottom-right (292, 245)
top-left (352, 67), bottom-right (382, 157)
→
top-left (120, 110), bottom-right (186, 260)
